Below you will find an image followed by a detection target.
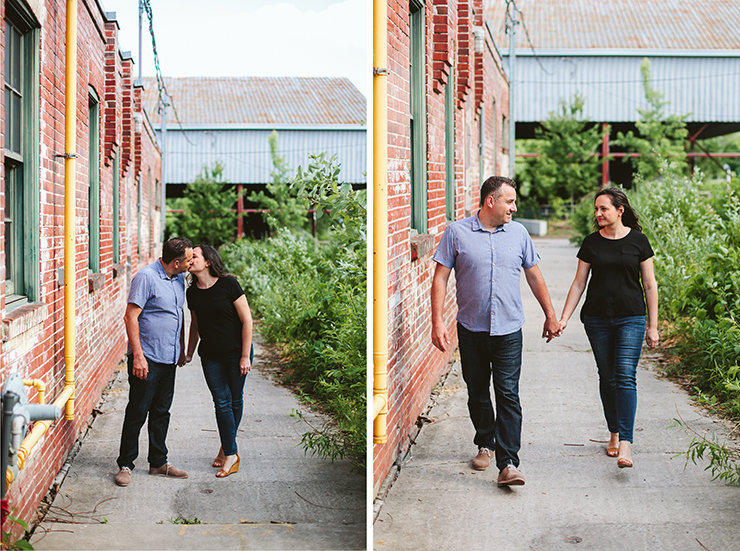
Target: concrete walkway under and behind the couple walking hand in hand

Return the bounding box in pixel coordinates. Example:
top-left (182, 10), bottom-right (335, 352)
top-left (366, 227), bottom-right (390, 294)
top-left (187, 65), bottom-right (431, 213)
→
top-left (373, 239), bottom-right (740, 551)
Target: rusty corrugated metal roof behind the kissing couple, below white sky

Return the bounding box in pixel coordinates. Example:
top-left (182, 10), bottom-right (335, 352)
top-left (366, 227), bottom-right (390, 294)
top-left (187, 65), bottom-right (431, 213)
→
top-left (144, 77), bottom-right (367, 126)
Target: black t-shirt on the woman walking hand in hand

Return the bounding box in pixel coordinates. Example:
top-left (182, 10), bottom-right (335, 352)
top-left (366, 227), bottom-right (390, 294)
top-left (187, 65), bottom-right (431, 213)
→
top-left (577, 230), bottom-right (653, 318)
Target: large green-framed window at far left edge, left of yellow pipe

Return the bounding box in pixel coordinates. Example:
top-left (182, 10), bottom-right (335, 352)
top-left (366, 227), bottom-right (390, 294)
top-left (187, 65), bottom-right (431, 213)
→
top-left (4, 2), bottom-right (41, 309)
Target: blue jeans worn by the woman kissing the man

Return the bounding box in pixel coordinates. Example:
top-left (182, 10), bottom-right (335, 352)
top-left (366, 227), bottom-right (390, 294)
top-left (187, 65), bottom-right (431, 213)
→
top-left (200, 345), bottom-right (254, 455)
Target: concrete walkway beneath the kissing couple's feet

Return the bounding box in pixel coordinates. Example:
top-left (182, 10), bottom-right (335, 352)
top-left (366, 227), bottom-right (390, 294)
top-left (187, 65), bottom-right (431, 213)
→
top-left (31, 332), bottom-right (367, 551)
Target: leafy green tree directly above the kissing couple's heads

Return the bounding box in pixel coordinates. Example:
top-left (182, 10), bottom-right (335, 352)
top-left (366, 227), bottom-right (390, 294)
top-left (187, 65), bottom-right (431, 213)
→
top-left (166, 161), bottom-right (239, 247)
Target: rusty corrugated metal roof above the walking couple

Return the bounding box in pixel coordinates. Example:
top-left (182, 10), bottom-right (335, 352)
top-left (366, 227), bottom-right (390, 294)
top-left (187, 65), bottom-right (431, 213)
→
top-left (484, 0), bottom-right (740, 51)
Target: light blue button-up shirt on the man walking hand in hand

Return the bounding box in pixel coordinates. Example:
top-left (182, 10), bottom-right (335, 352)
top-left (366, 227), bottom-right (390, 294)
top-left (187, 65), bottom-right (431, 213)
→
top-left (433, 213), bottom-right (540, 336)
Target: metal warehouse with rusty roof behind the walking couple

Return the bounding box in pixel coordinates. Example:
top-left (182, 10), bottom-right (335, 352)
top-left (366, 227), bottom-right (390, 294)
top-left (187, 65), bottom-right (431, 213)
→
top-left (486, 0), bottom-right (740, 185)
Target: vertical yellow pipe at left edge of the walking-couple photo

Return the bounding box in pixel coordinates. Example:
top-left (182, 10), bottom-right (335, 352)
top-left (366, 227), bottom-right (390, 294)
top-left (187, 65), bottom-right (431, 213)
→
top-left (373, 0), bottom-right (388, 444)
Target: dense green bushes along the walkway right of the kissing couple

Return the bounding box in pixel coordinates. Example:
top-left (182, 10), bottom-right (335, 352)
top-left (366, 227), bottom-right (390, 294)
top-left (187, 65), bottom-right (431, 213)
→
top-left (221, 155), bottom-right (367, 468)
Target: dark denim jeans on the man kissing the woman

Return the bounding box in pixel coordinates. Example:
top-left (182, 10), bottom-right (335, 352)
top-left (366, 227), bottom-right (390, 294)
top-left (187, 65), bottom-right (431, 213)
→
top-left (117, 354), bottom-right (177, 470)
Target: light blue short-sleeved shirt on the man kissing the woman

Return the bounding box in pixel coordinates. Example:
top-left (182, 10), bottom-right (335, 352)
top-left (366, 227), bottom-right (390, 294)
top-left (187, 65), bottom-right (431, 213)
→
top-left (128, 259), bottom-right (185, 364)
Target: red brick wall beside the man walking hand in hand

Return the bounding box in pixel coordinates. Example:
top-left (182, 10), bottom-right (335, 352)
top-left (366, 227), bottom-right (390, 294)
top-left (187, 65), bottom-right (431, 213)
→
top-left (373, 0), bottom-right (508, 493)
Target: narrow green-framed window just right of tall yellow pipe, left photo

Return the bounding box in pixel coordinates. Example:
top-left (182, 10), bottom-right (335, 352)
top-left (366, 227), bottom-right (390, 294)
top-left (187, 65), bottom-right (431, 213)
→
top-left (87, 88), bottom-right (100, 273)
